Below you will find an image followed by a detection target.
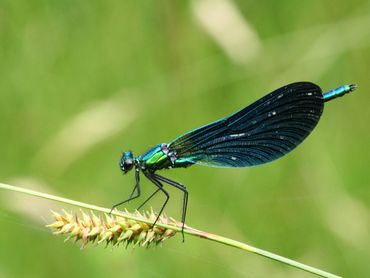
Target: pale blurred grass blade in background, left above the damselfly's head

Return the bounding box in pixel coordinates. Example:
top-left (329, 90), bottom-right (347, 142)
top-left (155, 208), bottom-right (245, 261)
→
top-left (35, 97), bottom-right (136, 173)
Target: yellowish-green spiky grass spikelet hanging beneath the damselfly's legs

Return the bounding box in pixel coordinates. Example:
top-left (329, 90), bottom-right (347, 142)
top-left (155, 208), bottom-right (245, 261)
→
top-left (47, 210), bottom-right (178, 248)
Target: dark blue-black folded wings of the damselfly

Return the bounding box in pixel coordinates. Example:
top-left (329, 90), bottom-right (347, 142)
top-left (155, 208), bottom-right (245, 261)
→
top-left (169, 82), bottom-right (324, 167)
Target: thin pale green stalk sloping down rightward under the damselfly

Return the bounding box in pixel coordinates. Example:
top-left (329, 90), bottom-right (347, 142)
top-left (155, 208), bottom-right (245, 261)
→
top-left (0, 183), bottom-right (340, 278)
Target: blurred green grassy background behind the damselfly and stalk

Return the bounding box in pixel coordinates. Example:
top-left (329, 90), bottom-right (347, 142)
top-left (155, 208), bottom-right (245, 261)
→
top-left (0, 0), bottom-right (370, 277)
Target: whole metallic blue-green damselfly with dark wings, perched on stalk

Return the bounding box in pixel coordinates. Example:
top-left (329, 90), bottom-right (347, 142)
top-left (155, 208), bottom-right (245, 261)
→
top-left (117, 82), bottom-right (356, 236)
